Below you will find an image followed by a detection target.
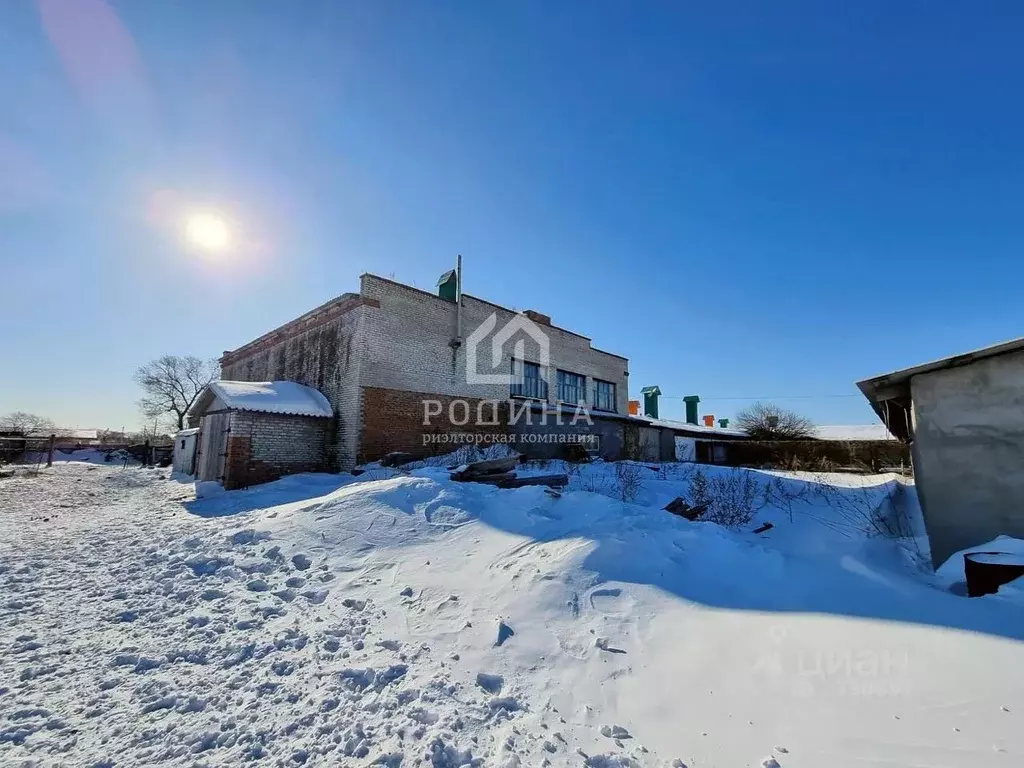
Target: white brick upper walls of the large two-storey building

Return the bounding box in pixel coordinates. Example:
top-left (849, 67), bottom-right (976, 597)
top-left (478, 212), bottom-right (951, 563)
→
top-left (221, 274), bottom-right (629, 469)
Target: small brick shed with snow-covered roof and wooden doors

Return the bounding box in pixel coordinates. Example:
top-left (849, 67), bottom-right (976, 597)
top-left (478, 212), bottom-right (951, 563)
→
top-left (188, 381), bottom-right (334, 489)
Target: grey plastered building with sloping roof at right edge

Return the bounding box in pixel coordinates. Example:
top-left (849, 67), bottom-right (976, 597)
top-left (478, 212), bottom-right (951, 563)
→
top-left (857, 339), bottom-right (1024, 565)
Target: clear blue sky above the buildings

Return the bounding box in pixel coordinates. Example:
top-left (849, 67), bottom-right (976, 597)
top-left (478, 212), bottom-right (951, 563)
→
top-left (0, 0), bottom-right (1024, 427)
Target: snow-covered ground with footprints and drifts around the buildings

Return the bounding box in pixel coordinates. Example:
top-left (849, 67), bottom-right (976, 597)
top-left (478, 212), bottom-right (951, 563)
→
top-left (0, 462), bottom-right (1024, 768)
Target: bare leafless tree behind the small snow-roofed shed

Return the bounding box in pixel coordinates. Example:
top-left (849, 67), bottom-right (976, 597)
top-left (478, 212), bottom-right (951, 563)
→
top-left (135, 354), bottom-right (220, 430)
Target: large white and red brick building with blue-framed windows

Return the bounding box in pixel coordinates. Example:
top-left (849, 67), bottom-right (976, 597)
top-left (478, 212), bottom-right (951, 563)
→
top-left (210, 274), bottom-right (629, 471)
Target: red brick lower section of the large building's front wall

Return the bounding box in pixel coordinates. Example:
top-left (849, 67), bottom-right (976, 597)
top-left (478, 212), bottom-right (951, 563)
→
top-left (358, 387), bottom-right (508, 463)
